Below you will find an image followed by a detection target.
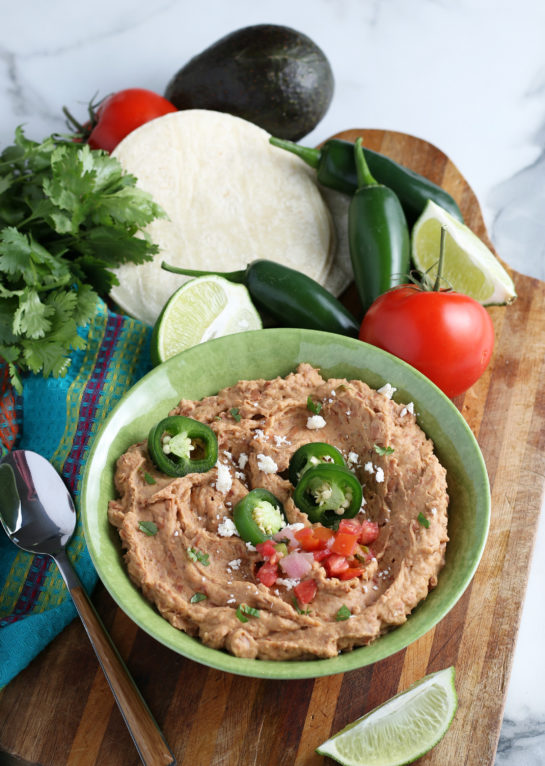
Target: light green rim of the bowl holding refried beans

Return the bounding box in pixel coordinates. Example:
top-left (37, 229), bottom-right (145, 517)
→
top-left (80, 328), bottom-right (490, 680)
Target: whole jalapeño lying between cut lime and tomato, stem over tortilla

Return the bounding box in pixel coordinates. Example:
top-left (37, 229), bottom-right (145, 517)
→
top-left (162, 259), bottom-right (359, 336)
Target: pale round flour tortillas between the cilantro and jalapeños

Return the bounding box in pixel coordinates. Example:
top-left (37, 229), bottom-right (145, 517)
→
top-left (111, 109), bottom-right (349, 325)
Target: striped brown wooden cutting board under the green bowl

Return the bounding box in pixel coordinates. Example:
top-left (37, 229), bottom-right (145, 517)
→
top-left (0, 130), bottom-right (545, 766)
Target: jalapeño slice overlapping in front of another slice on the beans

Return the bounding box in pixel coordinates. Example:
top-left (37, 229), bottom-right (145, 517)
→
top-left (293, 463), bottom-right (363, 527)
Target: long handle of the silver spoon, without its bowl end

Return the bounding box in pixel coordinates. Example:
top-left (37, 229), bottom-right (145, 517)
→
top-left (54, 551), bottom-right (176, 766)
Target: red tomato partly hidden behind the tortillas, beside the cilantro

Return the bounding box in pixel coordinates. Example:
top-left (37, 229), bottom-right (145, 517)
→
top-left (88, 88), bottom-right (178, 152)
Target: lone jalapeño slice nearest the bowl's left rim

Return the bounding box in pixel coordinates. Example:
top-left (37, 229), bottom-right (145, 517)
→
top-left (148, 415), bottom-right (218, 476)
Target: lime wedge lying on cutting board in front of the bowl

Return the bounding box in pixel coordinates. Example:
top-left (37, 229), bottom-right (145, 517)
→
top-left (316, 667), bottom-right (458, 766)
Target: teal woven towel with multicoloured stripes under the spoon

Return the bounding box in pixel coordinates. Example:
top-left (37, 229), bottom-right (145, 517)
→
top-left (0, 300), bottom-right (151, 688)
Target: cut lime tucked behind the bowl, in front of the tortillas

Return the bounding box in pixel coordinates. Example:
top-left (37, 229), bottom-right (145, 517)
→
top-left (151, 275), bottom-right (263, 364)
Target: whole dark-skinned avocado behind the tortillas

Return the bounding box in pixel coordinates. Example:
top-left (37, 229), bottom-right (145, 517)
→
top-left (165, 24), bottom-right (334, 141)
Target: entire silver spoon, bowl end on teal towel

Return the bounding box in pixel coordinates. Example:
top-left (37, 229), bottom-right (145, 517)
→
top-left (0, 450), bottom-right (176, 766)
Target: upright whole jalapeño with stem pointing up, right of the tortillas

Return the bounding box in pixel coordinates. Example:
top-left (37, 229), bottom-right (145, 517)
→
top-left (348, 138), bottom-right (410, 312)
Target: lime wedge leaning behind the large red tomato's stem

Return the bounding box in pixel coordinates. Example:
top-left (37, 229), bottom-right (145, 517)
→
top-left (411, 200), bottom-right (516, 306)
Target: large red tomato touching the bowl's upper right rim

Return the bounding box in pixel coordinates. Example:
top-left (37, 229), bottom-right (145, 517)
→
top-left (359, 285), bottom-right (494, 397)
